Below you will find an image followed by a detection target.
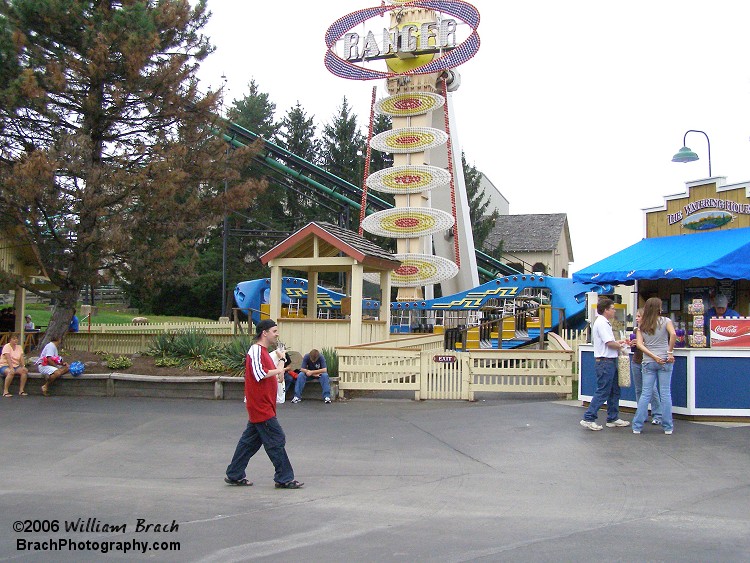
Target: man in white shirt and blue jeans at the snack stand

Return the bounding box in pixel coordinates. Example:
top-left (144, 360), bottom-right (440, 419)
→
top-left (581, 298), bottom-right (630, 430)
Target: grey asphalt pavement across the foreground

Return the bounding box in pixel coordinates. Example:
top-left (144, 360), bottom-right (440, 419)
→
top-left (0, 396), bottom-right (750, 563)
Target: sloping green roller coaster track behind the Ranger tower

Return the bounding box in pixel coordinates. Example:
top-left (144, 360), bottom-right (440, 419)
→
top-left (222, 121), bottom-right (520, 279)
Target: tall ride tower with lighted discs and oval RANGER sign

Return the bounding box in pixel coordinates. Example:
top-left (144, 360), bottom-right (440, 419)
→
top-left (325, 0), bottom-right (479, 301)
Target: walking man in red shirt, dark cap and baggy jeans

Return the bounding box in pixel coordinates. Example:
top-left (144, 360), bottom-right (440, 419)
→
top-left (224, 319), bottom-right (304, 489)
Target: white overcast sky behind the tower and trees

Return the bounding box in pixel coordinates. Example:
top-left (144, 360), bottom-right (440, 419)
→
top-left (199, 0), bottom-right (750, 272)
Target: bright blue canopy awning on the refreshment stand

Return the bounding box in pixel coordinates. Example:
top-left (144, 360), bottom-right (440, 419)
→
top-left (573, 227), bottom-right (750, 285)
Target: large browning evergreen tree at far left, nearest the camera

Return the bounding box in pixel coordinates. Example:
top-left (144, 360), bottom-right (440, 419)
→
top-left (0, 0), bottom-right (263, 341)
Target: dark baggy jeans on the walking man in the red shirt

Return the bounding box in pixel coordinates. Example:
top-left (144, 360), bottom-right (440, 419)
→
top-left (227, 416), bottom-right (294, 483)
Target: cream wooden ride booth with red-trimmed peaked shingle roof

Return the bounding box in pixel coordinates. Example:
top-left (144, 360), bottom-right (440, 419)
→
top-left (260, 221), bottom-right (401, 351)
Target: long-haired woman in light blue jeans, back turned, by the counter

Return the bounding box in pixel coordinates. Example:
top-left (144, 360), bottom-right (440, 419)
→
top-left (633, 297), bottom-right (677, 434)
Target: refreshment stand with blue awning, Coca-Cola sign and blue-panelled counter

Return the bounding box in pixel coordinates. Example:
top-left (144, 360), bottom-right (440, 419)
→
top-left (573, 177), bottom-right (750, 420)
